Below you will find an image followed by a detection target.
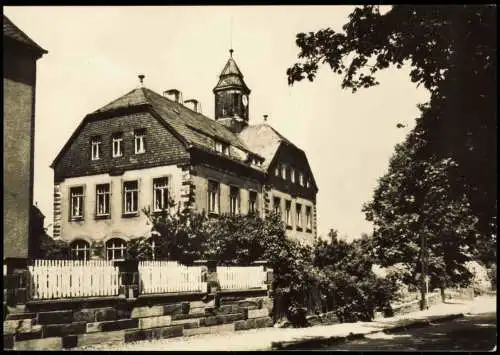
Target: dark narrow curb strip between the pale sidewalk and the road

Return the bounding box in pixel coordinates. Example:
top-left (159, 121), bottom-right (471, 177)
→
top-left (270, 313), bottom-right (464, 350)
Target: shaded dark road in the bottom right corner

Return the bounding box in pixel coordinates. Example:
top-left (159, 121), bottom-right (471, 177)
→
top-left (322, 312), bottom-right (497, 351)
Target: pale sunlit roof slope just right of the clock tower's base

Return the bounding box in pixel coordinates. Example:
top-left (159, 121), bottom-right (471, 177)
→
top-left (239, 123), bottom-right (300, 169)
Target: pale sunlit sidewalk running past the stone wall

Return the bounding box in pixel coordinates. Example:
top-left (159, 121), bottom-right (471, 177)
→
top-left (79, 296), bottom-right (496, 351)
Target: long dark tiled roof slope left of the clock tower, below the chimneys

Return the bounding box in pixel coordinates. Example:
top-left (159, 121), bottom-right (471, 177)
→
top-left (93, 88), bottom-right (255, 161)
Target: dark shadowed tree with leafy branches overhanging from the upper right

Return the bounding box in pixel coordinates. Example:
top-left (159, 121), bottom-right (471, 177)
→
top-left (287, 5), bottom-right (497, 263)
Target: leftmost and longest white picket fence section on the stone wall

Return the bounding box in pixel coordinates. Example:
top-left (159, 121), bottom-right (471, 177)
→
top-left (28, 260), bottom-right (120, 299)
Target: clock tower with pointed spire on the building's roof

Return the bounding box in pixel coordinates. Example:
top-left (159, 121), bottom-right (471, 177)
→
top-left (213, 49), bottom-right (250, 133)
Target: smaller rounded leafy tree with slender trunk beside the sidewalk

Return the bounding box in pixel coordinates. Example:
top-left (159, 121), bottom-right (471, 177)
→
top-left (363, 132), bottom-right (478, 308)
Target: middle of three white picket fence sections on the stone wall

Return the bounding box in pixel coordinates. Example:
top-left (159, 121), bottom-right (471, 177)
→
top-left (139, 260), bottom-right (207, 294)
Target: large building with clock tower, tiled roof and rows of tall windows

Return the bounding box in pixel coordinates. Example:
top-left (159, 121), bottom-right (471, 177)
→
top-left (51, 50), bottom-right (318, 259)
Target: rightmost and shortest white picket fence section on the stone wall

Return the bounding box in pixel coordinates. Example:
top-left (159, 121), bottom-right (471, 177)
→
top-left (217, 266), bottom-right (267, 290)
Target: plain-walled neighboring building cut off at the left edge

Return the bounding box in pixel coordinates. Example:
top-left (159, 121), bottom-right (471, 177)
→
top-left (3, 16), bottom-right (47, 258)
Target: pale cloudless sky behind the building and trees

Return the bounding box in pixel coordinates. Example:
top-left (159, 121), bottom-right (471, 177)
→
top-left (4, 5), bottom-right (429, 240)
